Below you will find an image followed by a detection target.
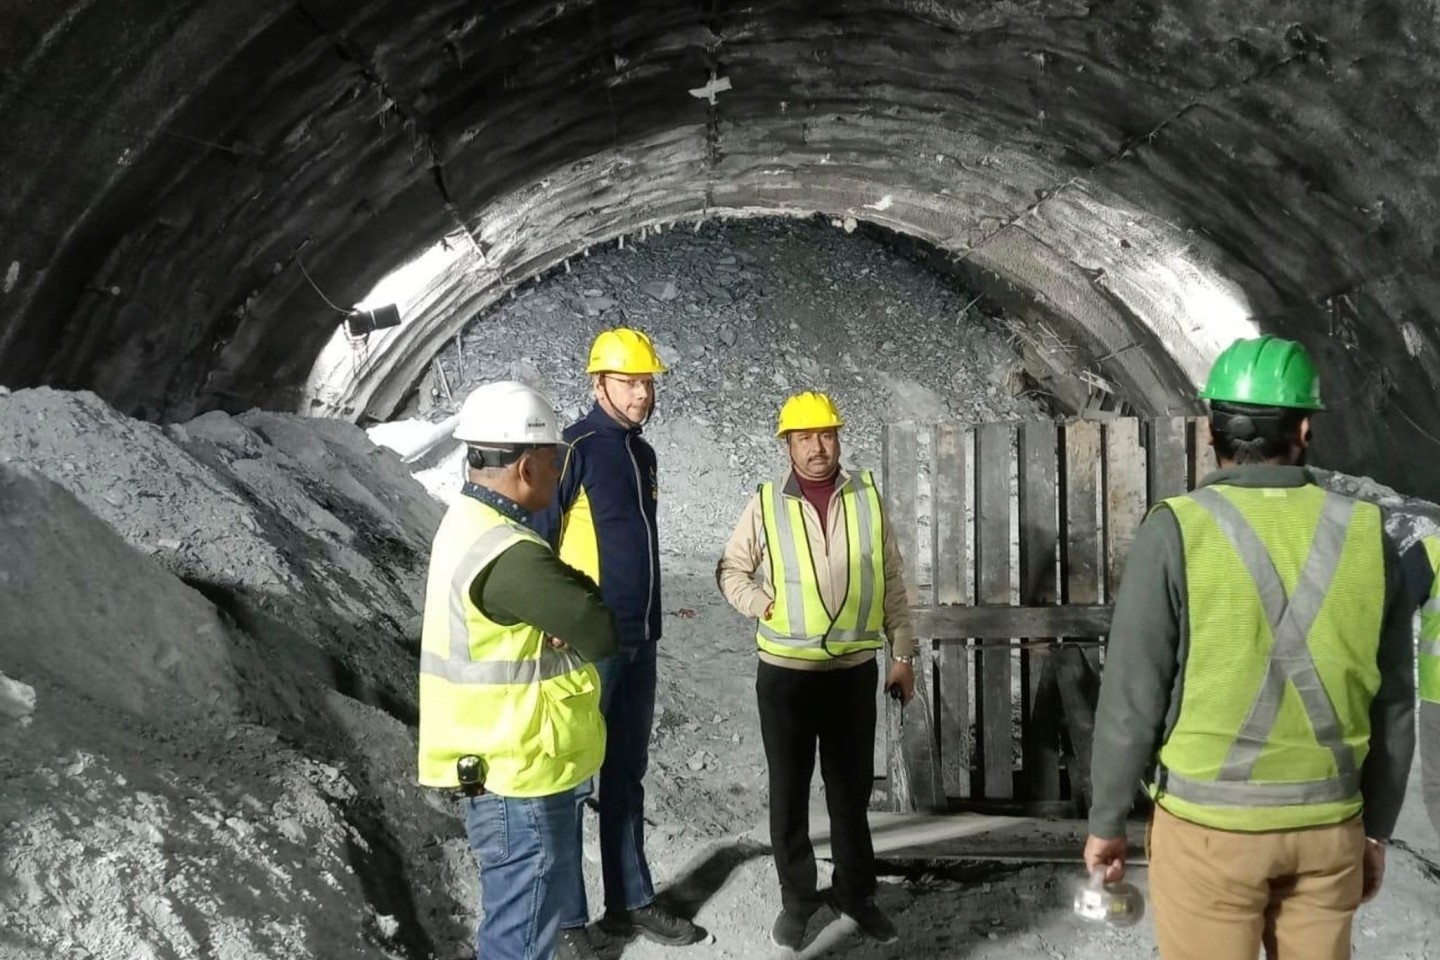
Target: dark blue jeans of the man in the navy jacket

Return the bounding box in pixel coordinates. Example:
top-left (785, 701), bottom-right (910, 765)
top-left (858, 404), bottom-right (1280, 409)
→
top-left (558, 643), bottom-right (655, 926)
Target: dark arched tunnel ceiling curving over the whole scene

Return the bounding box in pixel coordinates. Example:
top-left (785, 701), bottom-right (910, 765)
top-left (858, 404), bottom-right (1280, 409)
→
top-left (0, 0), bottom-right (1440, 498)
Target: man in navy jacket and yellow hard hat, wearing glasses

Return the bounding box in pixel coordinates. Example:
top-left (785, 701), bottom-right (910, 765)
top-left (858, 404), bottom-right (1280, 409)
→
top-left (537, 327), bottom-right (706, 946)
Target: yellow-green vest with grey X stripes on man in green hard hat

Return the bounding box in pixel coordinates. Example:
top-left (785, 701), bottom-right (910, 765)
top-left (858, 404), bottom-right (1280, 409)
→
top-left (1153, 485), bottom-right (1385, 830)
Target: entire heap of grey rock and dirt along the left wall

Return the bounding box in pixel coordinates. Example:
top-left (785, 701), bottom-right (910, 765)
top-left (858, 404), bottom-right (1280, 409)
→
top-left (0, 389), bottom-right (460, 960)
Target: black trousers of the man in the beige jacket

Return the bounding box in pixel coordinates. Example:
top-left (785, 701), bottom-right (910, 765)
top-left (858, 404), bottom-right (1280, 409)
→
top-left (755, 661), bottom-right (878, 913)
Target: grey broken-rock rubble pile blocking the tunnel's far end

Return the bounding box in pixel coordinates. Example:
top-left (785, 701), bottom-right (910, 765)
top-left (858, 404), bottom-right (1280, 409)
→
top-left (422, 219), bottom-right (1047, 553)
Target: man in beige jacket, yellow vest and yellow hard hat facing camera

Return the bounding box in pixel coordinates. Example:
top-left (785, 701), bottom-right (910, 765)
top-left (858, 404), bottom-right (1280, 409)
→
top-left (716, 393), bottom-right (916, 950)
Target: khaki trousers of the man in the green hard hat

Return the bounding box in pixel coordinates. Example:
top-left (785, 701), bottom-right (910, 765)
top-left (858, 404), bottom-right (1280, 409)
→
top-left (1146, 807), bottom-right (1365, 960)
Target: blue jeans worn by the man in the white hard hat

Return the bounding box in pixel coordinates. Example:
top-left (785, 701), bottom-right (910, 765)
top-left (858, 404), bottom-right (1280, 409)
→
top-left (465, 780), bottom-right (590, 960)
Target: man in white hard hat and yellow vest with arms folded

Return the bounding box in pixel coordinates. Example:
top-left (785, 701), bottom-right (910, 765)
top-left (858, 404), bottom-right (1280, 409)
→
top-left (419, 381), bottom-right (619, 960)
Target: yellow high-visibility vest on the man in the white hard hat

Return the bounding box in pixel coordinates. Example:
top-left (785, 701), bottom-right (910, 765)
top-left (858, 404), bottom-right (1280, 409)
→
top-left (419, 497), bottom-right (605, 797)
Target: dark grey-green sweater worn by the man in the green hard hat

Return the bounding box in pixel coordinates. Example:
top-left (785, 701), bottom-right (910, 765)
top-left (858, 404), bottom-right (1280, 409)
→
top-left (1090, 466), bottom-right (1416, 839)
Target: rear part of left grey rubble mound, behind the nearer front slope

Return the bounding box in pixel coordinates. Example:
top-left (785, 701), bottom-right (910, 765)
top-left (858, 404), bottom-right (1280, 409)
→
top-left (0, 389), bottom-right (439, 720)
